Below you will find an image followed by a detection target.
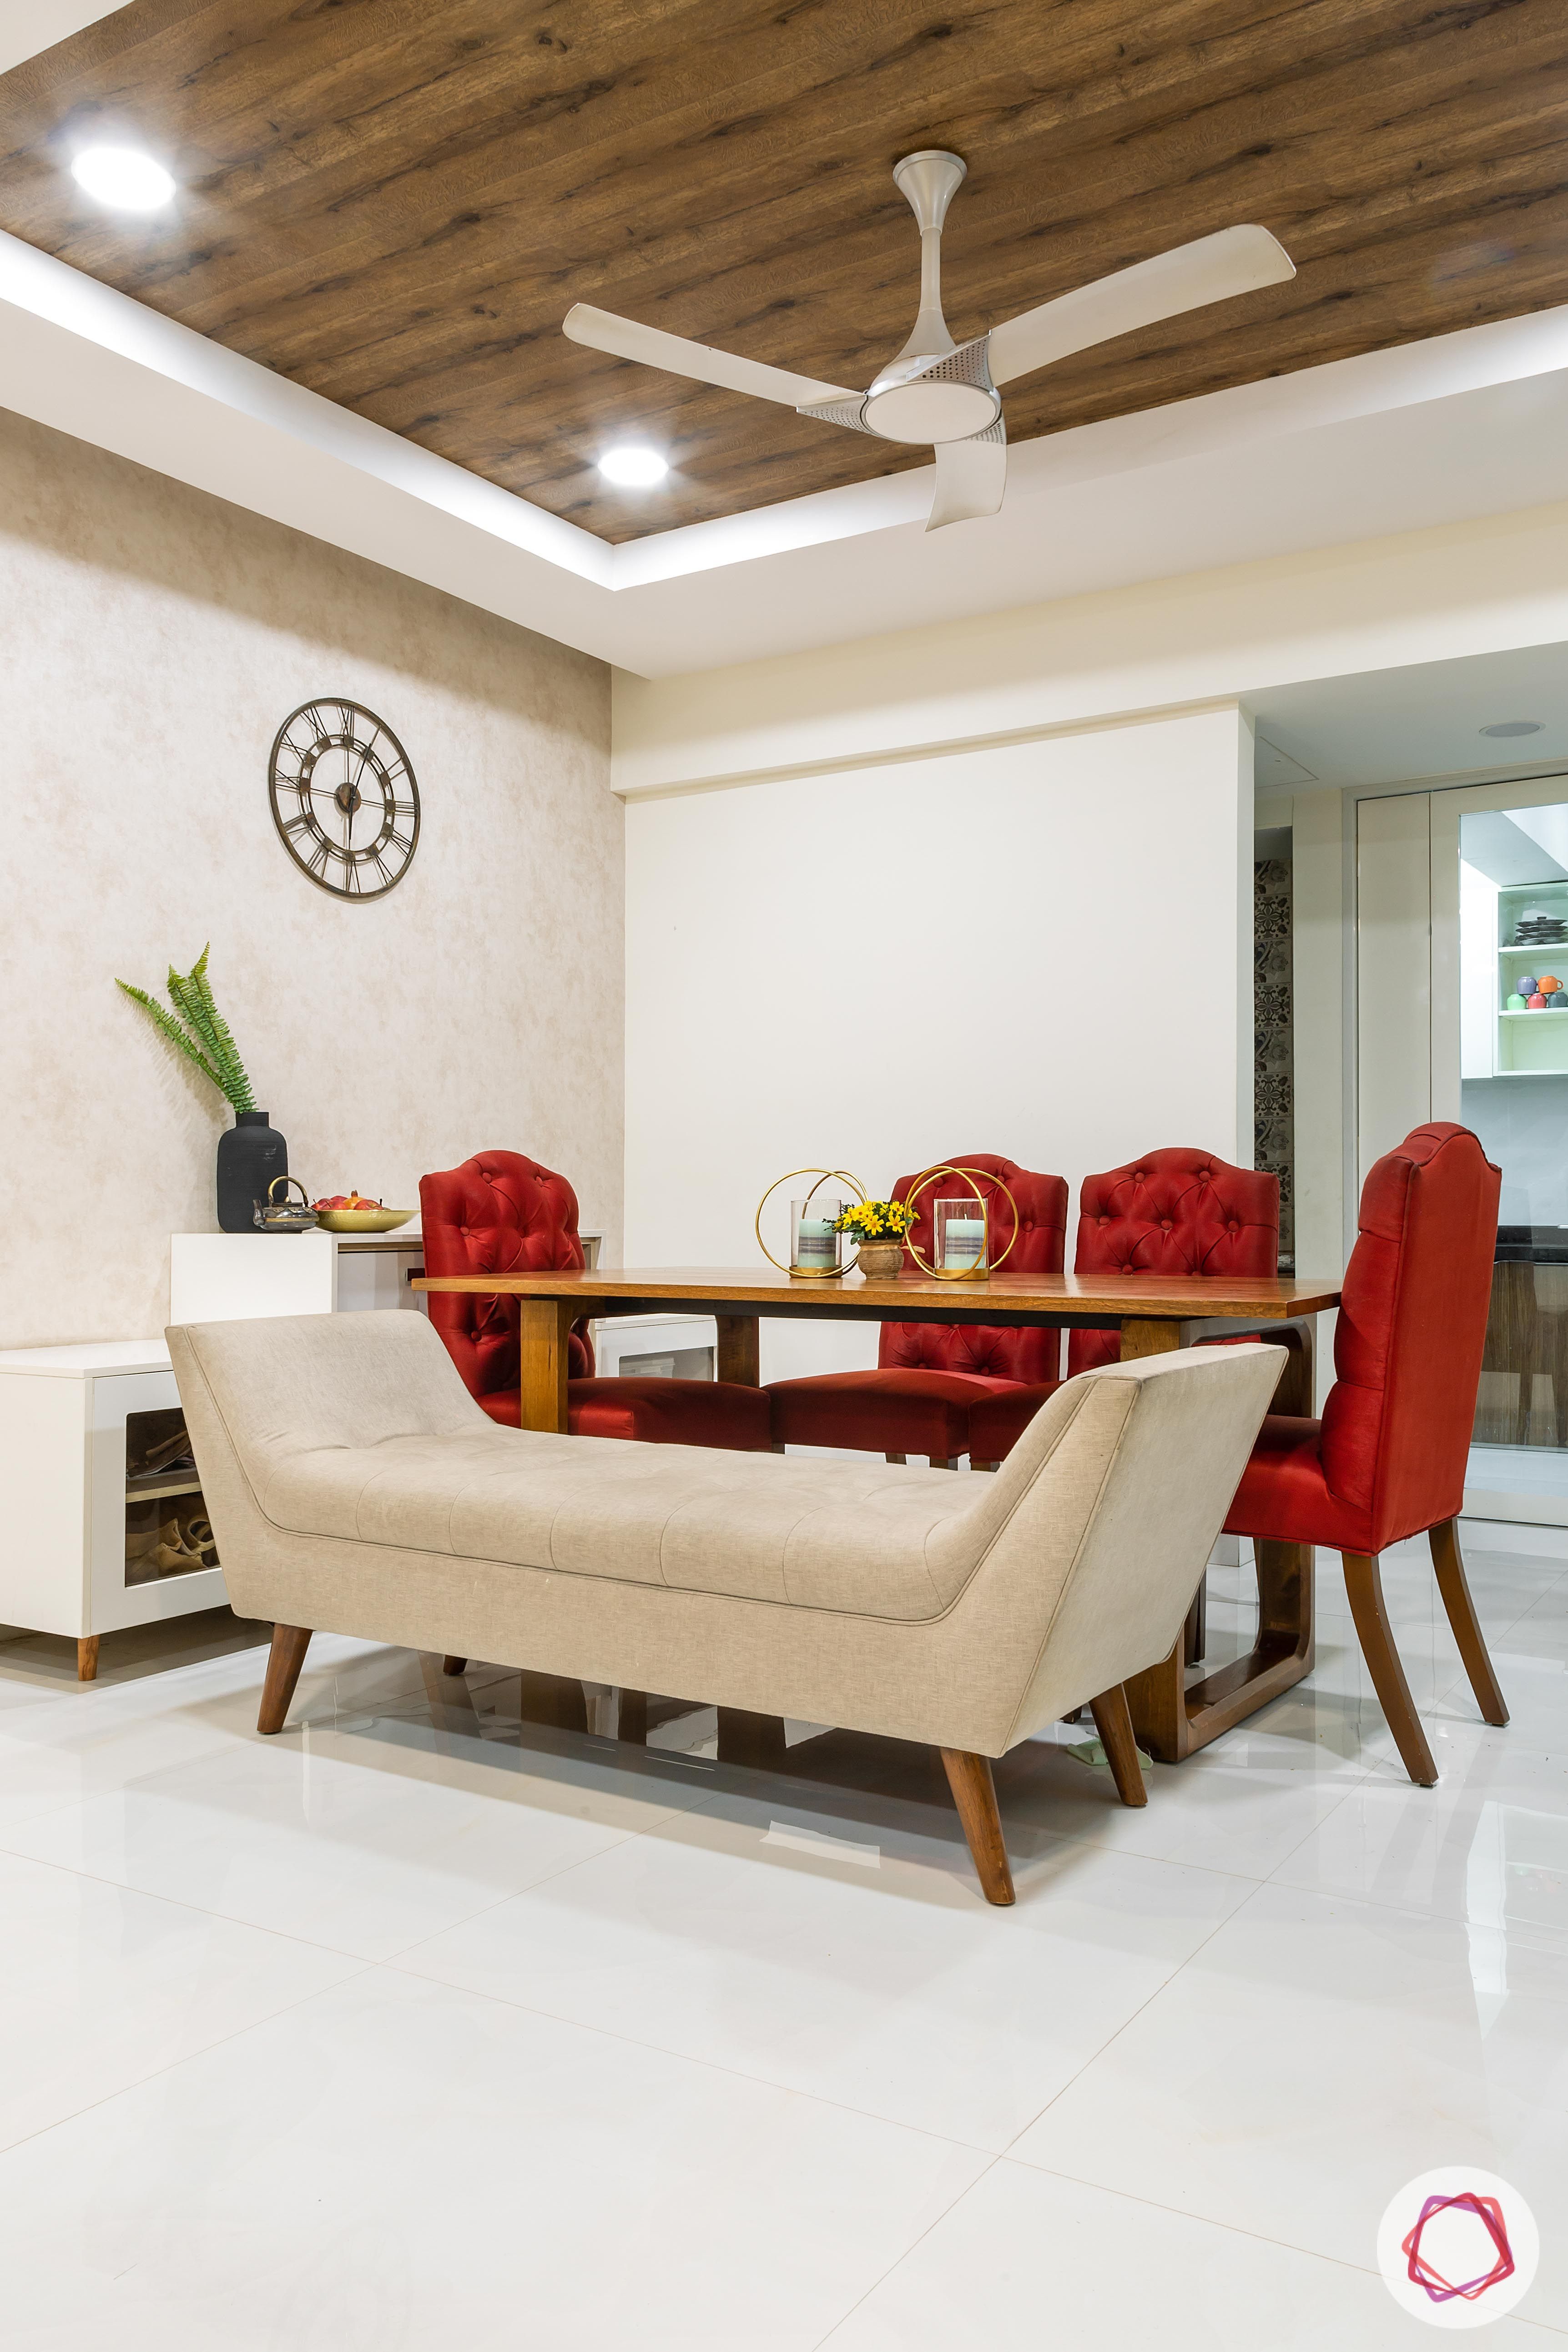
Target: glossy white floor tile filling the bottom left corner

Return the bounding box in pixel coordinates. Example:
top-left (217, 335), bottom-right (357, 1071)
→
top-left (0, 1968), bottom-right (985, 2352)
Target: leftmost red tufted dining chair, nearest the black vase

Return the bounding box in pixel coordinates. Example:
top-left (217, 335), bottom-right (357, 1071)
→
top-left (418, 1152), bottom-right (771, 1454)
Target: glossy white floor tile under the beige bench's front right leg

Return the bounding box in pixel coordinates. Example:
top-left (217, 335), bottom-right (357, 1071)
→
top-left (400, 1767), bottom-right (1250, 2150)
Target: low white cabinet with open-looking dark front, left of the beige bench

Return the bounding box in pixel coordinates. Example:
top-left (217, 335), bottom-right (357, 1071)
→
top-left (0, 1338), bottom-right (228, 1682)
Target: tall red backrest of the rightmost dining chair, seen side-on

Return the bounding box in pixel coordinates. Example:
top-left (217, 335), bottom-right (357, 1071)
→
top-left (1321, 1122), bottom-right (1502, 1552)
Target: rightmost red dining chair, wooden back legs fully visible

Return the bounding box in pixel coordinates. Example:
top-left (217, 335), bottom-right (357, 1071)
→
top-left (1225, 1122), bottom-right (1509, 1787)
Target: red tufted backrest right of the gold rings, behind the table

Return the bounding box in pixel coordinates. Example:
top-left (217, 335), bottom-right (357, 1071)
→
top-left (1067, 1146), bottom-right (1279, 1371)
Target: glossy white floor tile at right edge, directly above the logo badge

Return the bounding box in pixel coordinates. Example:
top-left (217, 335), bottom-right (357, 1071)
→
top-left (1013, 1886), bottom-right (1568, 2328)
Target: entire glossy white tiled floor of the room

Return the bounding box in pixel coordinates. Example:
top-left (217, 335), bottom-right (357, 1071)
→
top-left (0, 1531), bottom-right (1568, 2352)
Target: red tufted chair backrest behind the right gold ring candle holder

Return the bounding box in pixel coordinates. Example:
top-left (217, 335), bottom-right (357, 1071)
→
top-left (877, 1152), bottom-right (1067, 1381)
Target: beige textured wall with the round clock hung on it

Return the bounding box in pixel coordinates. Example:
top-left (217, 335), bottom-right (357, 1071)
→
top-left (0, 412), bottom-right (623, 1348)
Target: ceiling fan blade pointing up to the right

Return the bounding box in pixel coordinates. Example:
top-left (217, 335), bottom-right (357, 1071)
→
top-left (990, 223), bottom-right (1296, 384)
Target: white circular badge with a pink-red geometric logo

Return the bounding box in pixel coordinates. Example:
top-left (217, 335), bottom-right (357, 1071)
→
top-left (1377, 2164), bottom-right (1540, 2328)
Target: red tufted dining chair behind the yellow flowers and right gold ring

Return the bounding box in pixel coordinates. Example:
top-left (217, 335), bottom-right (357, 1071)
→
top-left (766, 1152), bottom-right (1067, 1470)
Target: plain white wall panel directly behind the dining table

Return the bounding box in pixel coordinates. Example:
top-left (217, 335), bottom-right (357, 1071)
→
top-left (625, 708), bottom-right (1253, 1378)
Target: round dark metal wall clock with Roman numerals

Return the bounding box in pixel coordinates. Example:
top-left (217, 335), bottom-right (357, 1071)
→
top-left (268, 696), bottom-right (418, 898)
